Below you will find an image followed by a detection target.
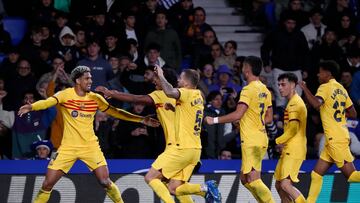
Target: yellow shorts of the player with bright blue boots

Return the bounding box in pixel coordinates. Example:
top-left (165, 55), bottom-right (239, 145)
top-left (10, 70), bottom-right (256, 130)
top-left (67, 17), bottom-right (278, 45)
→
top-left (151, 147), bottom-right (201, 181)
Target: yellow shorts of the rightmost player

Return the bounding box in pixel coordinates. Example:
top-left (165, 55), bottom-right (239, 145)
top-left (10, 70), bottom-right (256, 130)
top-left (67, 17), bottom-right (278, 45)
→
top-left (320, 142), bottom-right (354, 168)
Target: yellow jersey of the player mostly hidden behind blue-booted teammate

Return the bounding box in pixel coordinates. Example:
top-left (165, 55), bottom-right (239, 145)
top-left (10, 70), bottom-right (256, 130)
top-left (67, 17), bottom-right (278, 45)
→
top-left (149, 90), bottom-right (176, 146)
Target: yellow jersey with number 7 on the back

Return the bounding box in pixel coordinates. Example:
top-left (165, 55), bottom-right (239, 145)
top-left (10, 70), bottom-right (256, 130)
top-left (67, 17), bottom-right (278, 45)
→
top-left (239, 81), bottom-right (271, 146)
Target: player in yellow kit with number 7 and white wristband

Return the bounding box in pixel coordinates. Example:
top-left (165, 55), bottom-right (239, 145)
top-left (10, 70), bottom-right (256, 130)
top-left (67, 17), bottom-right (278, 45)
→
top-left (205, 56), bottom-right (274, 202)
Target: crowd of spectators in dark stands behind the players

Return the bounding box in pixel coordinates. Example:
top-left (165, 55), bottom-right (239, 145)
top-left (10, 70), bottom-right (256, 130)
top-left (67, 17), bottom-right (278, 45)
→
top-left (0, 0), bottom-right (360, 159)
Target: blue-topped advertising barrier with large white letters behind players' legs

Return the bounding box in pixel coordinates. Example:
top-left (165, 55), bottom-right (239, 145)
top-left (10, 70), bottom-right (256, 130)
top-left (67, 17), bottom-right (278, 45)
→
top-left (0, 160), bottom-right (360, 203)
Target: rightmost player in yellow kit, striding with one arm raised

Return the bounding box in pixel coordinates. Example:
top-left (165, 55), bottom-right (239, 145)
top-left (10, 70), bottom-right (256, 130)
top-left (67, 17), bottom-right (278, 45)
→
top-left (299, 61), bottom-right (360, 203)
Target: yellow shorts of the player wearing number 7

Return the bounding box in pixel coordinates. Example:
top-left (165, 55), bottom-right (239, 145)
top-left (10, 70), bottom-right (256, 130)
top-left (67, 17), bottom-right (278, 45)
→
top-left (241, 145), bottom-right (267, 174)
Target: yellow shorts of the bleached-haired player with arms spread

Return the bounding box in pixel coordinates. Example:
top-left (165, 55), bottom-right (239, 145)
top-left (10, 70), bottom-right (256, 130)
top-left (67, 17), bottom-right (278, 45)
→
top-left (48, 145), bottom-right (107, 173)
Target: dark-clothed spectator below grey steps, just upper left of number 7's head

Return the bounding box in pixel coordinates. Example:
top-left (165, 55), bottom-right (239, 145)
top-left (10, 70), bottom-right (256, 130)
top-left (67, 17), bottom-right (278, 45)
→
top-left (214, 40), bottom-right (237, 70)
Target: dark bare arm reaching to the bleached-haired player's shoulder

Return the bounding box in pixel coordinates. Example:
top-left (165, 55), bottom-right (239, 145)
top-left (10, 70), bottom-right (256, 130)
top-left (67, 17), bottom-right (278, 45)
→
top-left (95, 86), bottom-right (154, 106)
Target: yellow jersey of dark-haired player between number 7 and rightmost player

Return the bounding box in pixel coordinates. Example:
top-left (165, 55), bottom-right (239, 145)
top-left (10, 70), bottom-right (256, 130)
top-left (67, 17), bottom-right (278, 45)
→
top-left (277, 94), bottom-right (307, 160)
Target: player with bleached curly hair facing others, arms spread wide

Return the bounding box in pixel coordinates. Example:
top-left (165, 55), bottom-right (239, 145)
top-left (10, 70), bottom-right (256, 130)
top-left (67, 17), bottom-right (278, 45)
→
top-left (18, 66), bottom-right (159, 203)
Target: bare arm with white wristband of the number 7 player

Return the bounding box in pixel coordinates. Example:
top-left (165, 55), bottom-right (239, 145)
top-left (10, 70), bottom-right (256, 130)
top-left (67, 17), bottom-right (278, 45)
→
top-left (205, 103), bottom-right (248, 125)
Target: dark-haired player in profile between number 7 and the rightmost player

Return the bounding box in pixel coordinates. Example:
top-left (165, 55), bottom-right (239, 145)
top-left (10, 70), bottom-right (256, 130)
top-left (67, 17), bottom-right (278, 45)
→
top-left (274, 73), bottom-right (307, 203)
